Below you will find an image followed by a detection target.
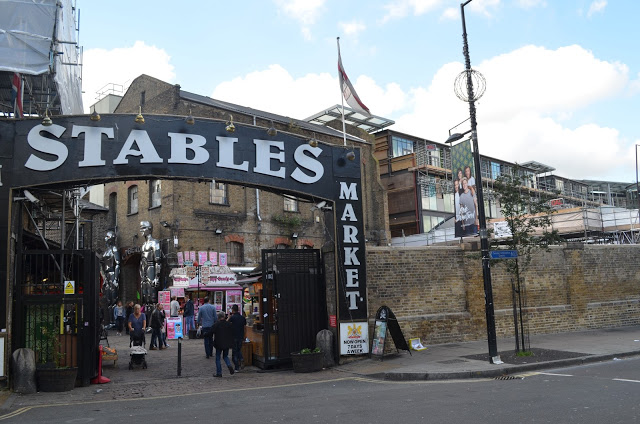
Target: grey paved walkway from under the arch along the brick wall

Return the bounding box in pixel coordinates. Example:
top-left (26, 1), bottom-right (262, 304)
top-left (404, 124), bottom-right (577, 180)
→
top-left (0, 326), bottom-right (640, 411)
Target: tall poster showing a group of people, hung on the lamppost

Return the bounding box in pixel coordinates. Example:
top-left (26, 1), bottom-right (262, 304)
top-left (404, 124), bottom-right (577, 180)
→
top-left (451, 140), bottom-right (480, 237)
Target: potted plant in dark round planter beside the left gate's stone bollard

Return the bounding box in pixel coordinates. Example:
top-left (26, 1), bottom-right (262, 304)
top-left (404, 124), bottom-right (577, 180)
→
top-left (36, 326), bottom-right (78, 392)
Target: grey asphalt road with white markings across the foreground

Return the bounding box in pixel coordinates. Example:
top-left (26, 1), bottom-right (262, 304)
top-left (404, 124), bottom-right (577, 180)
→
top-left (5, 357), bottom-right (640, 424)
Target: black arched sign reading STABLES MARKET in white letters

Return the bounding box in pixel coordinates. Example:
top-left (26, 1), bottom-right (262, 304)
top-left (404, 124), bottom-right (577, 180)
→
top-left (0, 114), bottom-right (367, 348)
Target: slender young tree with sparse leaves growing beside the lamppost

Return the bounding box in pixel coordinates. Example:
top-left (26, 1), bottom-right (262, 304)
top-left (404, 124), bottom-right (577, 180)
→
top-left (493, 167), bottom-right (559, 352)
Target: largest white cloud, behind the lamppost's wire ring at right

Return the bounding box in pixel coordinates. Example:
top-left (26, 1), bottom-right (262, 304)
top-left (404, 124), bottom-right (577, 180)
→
top-left (396, 46), bottom-right (628, 178)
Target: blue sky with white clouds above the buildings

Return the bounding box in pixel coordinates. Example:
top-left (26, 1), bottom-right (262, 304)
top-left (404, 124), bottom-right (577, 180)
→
top-left (76, 0), bottom-right (640, 183)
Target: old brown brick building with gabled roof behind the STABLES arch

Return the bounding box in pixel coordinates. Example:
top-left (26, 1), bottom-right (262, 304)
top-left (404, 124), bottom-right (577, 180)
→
top-left (104, 75), bottom-right (388, 306)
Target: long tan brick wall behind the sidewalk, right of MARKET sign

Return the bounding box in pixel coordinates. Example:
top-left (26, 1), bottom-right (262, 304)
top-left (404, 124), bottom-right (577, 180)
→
top-left (367, 245), bottom-right (640, 344)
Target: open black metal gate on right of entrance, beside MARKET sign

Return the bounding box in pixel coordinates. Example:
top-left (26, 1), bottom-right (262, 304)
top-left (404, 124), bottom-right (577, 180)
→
top-left (261, 249), bottom-right (327, 366)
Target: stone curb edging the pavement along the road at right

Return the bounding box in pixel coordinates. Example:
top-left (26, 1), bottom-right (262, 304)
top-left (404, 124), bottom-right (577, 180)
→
top-left (366, 351), bottom-right (640, 381)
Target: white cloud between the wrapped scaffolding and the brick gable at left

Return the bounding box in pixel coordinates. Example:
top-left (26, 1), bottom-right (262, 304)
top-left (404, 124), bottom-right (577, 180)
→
top-left (82, 41), bottom-right (176, 113)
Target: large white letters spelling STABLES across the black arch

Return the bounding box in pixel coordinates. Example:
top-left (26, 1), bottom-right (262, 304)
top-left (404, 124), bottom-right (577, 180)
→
top-left (24, 124), bottom-right (324, 182)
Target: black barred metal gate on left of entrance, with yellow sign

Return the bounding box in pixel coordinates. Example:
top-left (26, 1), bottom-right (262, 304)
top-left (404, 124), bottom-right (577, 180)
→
top-left (12, 250), bottom-right (100, 385)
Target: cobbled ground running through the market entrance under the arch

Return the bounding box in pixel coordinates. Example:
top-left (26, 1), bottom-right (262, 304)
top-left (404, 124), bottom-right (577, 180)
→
top-left (11, 331), bottom-right (347, 409)
